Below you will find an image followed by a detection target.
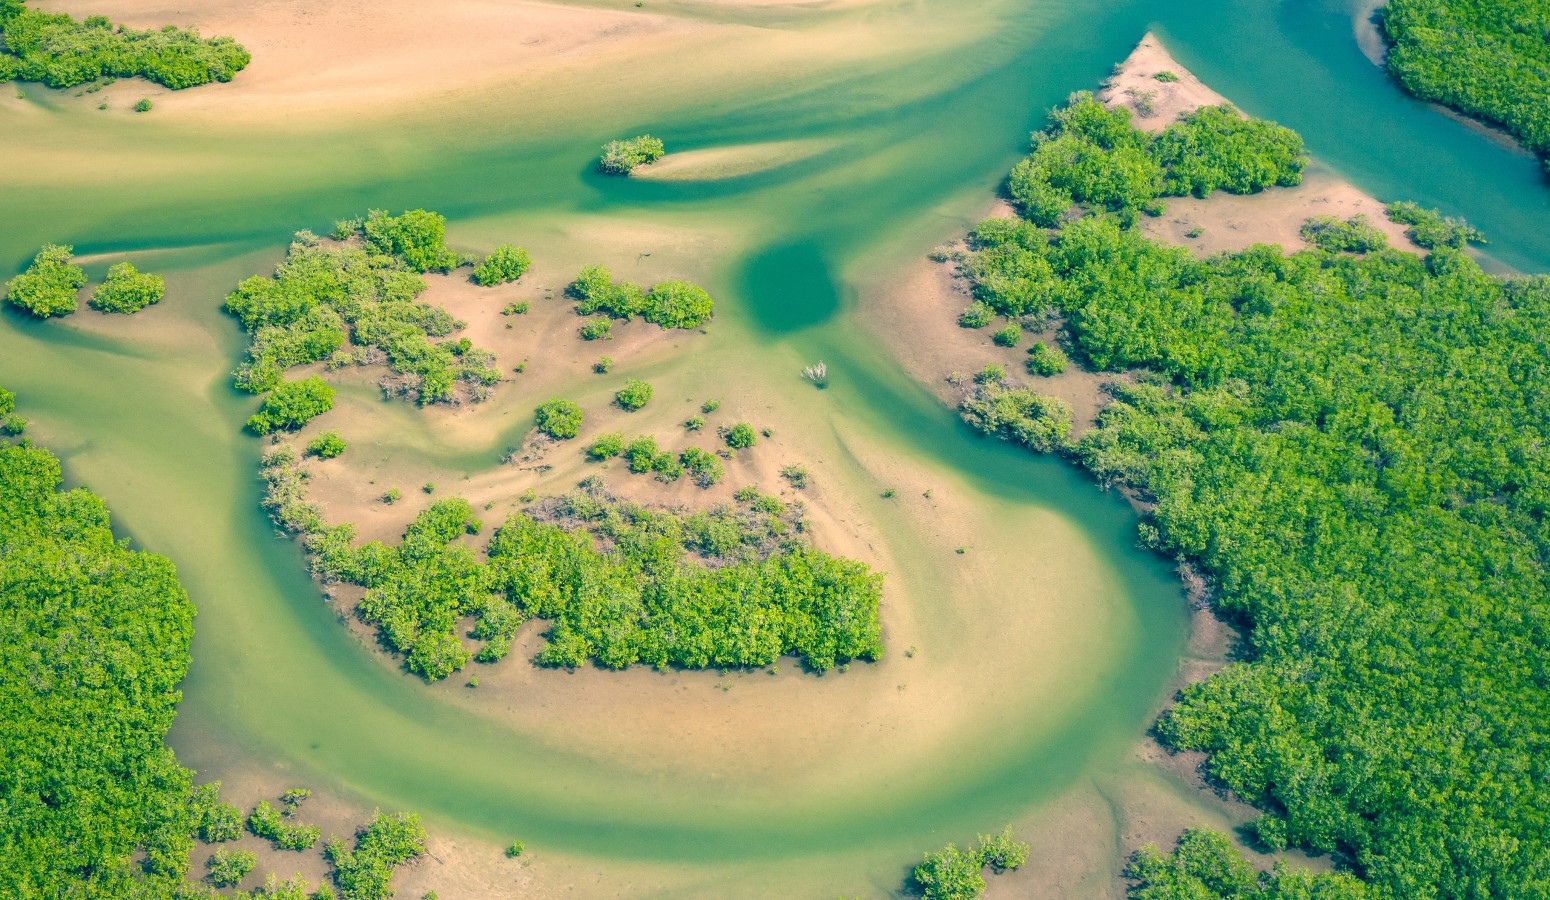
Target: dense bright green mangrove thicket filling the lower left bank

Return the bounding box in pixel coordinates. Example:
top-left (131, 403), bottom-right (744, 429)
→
top-left (0, 389), bottom-right (425, 900)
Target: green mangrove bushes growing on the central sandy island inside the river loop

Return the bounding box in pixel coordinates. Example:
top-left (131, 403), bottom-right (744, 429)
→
top-left (226, 211), bottom-right (882, 680)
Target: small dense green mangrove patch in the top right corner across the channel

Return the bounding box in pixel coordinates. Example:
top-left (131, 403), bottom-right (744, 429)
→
top-left (1380, 0), bottom-right (1550, 173)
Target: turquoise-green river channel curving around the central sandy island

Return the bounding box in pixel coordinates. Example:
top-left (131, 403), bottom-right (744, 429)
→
top-left (0, 0), bottom-right (1550, 895)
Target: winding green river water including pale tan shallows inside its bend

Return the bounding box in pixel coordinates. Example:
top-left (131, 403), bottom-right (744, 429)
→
top-left (0, 0), bottom-right (1550, 897)
